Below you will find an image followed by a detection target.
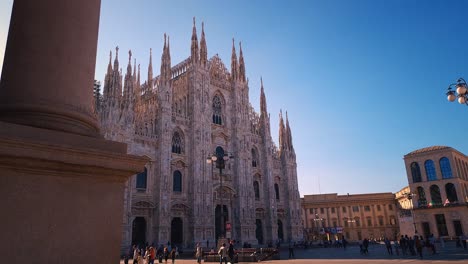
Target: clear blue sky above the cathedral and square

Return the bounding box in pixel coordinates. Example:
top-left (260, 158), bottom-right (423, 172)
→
top-left (0, 0), bottom-right (468, 196)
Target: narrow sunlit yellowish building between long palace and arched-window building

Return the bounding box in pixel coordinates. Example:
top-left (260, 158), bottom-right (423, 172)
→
top-left (395, 186), bottom-right (416, 236)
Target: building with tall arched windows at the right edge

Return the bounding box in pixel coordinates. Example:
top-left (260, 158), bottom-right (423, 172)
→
top-left (404, 146), bottom-right (468, 237)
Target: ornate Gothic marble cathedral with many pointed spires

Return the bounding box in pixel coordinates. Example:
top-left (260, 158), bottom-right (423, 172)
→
top-left (96, 21), bottom-right (303, 250)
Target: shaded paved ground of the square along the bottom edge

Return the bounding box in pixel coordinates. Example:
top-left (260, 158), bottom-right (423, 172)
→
top-left (121, 244), bottom-right (468, 264)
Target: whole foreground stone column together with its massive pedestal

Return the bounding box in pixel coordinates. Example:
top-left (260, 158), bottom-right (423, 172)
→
top-left (0, 0), bottom-right (148, 264)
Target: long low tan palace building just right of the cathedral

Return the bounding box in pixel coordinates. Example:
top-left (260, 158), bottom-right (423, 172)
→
top-left (301, 193), bottom-right (399, 241)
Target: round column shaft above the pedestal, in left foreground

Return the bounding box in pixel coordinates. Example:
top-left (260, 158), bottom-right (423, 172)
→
top-left (0, 0), bottom-right (101, 136)
